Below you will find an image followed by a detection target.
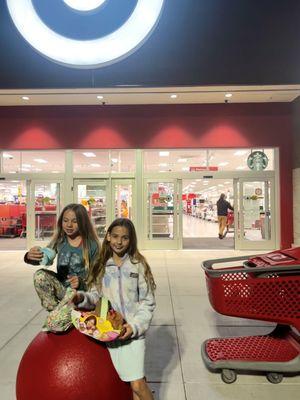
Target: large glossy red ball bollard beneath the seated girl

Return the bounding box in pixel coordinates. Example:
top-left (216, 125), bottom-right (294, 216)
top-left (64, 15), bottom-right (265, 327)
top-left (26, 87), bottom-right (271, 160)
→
top-left (16, 329), bottom-right (132, 400)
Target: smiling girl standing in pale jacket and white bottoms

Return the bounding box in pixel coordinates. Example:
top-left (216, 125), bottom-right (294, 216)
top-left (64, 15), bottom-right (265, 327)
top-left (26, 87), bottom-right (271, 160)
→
top-left (73, 218), bottom-right (156, 400)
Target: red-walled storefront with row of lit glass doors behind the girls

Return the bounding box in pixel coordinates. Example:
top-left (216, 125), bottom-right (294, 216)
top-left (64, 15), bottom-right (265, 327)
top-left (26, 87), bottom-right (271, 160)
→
top-left (0, 104), bottom-right (293, 250)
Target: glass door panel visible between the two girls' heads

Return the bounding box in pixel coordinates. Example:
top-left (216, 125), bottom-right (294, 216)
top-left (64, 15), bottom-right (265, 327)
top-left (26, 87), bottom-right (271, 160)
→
top-left (74, 180), bottom-right (108, 238)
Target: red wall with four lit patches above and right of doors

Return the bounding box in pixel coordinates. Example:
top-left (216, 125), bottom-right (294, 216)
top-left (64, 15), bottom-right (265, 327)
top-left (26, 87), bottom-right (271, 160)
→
top-left (0, 103), bottom-right (293, 247)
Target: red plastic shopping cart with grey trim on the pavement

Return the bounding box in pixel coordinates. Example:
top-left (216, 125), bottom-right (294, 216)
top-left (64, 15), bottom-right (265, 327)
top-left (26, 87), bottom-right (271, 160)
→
top-left (202, 248), bottom-right (300, 383)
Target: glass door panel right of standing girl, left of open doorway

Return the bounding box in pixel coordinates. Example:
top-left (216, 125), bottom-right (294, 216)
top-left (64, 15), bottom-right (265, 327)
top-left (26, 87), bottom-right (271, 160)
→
top-left (145, 180), bottom-right (181, 249)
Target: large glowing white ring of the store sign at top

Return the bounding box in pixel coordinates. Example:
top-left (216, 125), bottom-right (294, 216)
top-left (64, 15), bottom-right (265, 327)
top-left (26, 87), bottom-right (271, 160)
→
top-left (6, 0), bottom-right (164, 68)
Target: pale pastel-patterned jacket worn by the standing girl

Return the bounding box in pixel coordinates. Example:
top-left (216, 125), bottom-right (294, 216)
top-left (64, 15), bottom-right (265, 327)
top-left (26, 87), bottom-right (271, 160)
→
top-left (78, 254), bottom-right (155, 337)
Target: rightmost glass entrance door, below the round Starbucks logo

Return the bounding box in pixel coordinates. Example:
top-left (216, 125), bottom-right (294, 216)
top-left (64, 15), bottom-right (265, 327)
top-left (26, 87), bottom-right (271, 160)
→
top-left (234, 178), bottom-right (276, 250)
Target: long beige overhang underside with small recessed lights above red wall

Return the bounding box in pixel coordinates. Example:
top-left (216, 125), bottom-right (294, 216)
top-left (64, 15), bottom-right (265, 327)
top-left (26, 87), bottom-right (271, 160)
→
top-left (0, 85), bottom-right (300, 106)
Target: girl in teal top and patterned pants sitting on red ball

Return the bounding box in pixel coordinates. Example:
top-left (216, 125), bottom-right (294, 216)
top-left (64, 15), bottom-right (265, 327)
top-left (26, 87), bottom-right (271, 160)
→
top-left (24, 203), bottom-right (100, 332)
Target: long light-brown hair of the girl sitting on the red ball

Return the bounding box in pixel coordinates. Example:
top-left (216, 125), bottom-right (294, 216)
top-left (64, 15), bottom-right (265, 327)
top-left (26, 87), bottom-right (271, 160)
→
top-left (48, 203), bottom-right (100, 270)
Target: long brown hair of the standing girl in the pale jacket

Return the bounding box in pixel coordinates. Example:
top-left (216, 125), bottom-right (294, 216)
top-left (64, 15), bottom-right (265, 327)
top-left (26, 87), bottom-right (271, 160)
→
top-left (87, 218), bottom-right (156, 293)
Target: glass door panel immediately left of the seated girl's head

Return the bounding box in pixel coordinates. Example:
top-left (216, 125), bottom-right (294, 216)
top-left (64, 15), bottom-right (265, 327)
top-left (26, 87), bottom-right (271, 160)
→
top-left (26, 180), bottom-right (62, 247)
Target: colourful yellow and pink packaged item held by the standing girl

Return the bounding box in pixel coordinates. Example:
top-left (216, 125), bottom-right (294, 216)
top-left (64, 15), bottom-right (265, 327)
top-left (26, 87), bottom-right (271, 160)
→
top-left (72, 297), bottom-right (124, 342)
